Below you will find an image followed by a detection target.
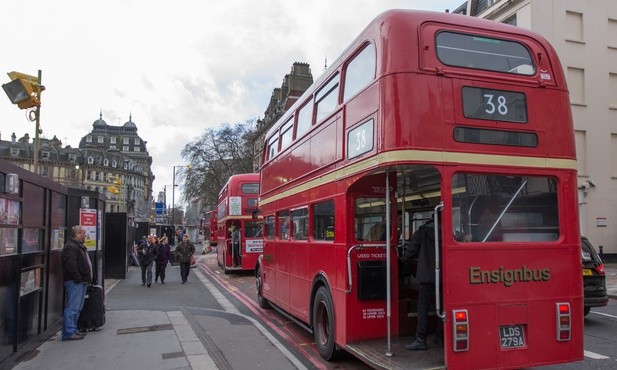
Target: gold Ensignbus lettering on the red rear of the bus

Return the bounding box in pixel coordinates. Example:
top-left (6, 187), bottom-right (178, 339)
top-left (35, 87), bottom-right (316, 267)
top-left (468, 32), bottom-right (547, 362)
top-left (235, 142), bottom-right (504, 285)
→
top-left (469, 265), bottom-right (551, 287)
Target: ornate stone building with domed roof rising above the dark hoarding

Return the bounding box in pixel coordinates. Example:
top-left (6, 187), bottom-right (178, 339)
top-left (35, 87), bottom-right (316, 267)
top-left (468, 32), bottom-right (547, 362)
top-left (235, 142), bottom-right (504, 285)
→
top-left (0, 113), bottom-right (154, 221)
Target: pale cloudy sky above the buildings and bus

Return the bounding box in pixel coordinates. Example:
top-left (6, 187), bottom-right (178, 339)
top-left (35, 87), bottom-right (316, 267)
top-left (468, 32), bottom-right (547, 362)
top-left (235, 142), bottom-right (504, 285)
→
top-left (0, 0), bottom-right (464, 205)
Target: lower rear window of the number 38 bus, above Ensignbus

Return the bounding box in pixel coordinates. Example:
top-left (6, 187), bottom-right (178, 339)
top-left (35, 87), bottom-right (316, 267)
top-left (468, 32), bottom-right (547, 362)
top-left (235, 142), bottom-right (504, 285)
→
top-left (452, 173), bottom-right (559, 243)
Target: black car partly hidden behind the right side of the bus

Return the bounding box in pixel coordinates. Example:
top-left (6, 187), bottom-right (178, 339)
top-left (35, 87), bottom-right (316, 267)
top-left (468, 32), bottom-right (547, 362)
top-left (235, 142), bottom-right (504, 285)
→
top-left (581, 236), bottom-right (608, 316)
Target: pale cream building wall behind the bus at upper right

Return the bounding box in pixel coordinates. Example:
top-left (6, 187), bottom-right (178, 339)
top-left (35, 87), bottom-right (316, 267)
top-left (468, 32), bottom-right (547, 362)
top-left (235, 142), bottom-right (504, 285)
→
top-left (467, 0), bottom-right (617, 257)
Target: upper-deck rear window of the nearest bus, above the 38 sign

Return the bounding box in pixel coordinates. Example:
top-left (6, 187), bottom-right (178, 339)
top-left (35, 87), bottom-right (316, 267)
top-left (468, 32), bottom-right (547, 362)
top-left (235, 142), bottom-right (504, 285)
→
top-left (435, 31), bottom-right (536, 76)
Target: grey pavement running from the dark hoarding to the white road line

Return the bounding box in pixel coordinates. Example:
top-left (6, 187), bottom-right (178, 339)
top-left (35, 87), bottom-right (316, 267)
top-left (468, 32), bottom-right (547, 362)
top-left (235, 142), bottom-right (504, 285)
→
top-left (7, 246), bottom-right (306, 370)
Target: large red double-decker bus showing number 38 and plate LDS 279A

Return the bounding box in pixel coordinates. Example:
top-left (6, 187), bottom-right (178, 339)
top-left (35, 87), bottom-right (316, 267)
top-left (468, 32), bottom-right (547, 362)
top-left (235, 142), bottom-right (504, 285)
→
top-left (256, 11), bottom-right (583, 369)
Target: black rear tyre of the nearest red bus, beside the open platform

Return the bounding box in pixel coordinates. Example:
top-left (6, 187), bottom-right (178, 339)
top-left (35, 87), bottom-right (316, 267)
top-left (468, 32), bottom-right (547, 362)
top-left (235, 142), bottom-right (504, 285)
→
top-left (313, 287), bottom-right (340, 361)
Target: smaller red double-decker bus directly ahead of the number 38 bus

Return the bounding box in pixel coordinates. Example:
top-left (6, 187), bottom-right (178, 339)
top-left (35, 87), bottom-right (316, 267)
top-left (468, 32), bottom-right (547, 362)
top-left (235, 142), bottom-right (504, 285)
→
top-left (216, 173), bottom-right (263, 274)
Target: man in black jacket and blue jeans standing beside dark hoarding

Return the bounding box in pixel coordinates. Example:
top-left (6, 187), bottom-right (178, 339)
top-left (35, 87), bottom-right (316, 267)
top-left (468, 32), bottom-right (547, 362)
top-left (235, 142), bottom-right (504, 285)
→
top-left (61, 226), bottom-right (92, 340)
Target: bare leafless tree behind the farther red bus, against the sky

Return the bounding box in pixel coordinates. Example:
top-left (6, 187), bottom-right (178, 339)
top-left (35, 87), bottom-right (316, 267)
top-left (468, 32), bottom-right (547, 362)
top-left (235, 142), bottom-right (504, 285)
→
top-left (179, 120), bottom-right (255, 209)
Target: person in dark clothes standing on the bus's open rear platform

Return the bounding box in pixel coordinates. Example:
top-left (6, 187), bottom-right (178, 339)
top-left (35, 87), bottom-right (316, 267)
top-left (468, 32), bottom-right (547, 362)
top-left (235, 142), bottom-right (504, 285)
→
top-left (403, 219), bottom-right (443, 351)
